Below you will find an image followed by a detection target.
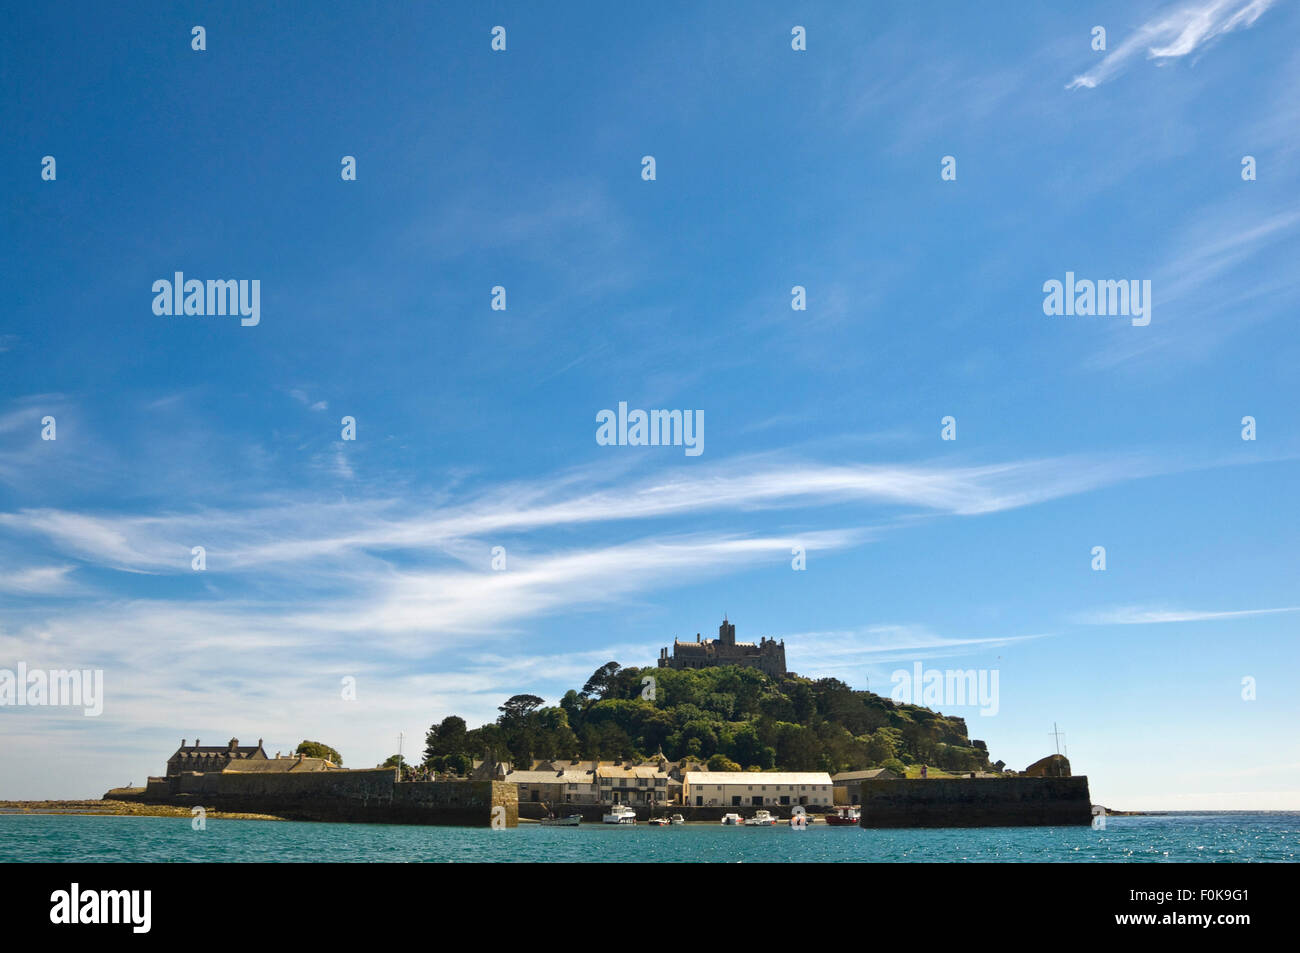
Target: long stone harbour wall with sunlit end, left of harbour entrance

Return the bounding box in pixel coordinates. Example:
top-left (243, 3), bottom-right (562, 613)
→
top-left (119, 768), bottom-right (519, 827)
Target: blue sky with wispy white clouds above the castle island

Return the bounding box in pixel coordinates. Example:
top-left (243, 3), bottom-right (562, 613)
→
top-left (0, 0), bottom-right (1300, 809)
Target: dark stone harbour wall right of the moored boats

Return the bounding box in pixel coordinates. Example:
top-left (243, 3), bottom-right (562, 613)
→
top-left (862, 775), bottom-right (1092, 827)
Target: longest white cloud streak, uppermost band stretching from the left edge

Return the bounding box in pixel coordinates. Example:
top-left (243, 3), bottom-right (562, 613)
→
top-left (0, 456), bottom-right (1161, 572)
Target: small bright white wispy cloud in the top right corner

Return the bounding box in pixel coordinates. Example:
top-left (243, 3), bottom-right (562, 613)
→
top-left (1066, 0), bottom-right (1274, 90)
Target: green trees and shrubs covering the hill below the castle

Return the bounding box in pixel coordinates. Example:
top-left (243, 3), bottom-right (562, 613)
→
top-left (424, 662), bottom-right (991, 775)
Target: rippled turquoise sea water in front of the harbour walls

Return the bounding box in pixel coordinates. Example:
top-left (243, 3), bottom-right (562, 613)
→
top-left (0, 813), bottom-right (1300, 862)
